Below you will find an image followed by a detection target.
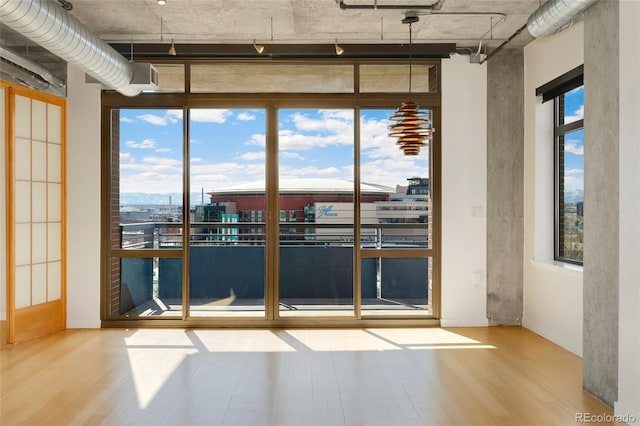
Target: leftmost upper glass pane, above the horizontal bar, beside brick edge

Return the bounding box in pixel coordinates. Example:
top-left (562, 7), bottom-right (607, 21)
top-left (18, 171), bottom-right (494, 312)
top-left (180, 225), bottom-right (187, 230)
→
top-left (111, 109), bottom-right (183, 250)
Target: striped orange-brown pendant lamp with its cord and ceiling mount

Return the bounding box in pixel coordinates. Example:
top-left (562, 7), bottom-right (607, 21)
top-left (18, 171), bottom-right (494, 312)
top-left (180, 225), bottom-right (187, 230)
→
top-left (387, 12), bottom-right (434, 155)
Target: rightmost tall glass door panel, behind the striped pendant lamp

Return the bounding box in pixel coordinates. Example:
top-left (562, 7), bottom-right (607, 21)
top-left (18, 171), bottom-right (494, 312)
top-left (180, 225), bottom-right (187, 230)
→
top-left (360, 110), bottom-right (435, 316)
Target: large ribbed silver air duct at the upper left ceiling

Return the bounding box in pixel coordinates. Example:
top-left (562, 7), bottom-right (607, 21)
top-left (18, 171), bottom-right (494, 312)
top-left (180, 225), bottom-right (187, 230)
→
top-left (0, 0), bottom-right (141, 96)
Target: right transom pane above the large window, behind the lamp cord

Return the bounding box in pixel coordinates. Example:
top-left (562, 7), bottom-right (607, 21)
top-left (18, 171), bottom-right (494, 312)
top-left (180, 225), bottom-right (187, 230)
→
top-left (360, 64), bottom-right (438, 93)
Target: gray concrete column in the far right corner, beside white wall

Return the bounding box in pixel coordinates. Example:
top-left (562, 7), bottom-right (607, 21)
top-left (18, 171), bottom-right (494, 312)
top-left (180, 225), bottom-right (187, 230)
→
top-left (487, 49), bottom-right (524, 325)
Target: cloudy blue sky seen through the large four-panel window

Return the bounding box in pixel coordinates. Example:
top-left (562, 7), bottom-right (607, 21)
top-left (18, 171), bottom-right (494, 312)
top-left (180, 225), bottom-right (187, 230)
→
top-left (120, 109), bottom-right (428, 197)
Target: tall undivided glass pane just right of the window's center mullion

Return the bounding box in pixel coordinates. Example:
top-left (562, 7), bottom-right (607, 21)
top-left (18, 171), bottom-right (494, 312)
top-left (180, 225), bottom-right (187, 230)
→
top-left (278, 109), bottom-right (354, 317)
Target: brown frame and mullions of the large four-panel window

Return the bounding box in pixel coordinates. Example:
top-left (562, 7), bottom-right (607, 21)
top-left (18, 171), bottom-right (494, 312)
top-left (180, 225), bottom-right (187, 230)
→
top-left (101, 58), bottom-right (442, 327)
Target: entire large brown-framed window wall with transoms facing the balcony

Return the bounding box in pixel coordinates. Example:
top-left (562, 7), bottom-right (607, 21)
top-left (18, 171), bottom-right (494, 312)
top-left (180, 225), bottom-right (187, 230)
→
top-left (102, 61), bottom-right (439, 326)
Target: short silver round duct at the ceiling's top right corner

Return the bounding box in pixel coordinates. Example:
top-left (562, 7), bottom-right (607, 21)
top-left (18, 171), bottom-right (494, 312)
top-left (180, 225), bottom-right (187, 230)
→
top-left (527, 0), bottom-right (598, 38)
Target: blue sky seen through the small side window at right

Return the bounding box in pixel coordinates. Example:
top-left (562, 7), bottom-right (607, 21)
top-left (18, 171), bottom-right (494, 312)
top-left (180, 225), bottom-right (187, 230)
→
top-left (564, 86), bottom-right (584, 195)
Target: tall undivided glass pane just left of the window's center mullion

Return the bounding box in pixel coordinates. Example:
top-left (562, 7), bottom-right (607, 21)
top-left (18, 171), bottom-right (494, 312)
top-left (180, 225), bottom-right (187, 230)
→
top-left (189, 109), bottom-right (266, 317)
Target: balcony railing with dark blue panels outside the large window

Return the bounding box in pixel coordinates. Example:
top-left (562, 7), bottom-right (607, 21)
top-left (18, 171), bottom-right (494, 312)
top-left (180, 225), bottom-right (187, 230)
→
top-left (119, 222), bottom-right (431, 314)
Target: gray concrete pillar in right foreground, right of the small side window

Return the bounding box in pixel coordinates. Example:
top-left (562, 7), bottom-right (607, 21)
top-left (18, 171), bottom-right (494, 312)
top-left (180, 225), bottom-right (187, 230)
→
top-left (583, 1), bottom-right (620, 406)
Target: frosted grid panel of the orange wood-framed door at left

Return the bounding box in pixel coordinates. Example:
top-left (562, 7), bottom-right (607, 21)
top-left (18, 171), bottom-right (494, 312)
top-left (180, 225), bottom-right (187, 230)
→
top-left (12, 95), bottom-right (63, 309)
